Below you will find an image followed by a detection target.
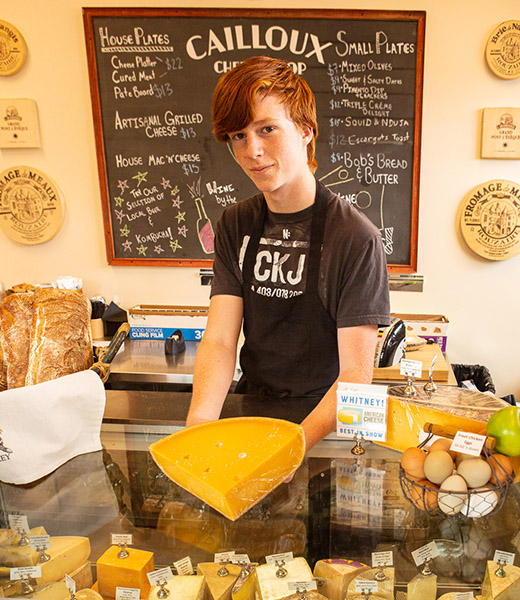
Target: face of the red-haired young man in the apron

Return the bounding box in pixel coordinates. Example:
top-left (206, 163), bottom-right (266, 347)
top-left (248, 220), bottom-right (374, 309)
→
top-left (229, 95), bottom-right (313, 202)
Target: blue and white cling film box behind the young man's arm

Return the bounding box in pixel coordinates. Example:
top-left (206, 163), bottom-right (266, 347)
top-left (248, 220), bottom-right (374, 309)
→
top-left (128, 304), bottom-right (208, 341)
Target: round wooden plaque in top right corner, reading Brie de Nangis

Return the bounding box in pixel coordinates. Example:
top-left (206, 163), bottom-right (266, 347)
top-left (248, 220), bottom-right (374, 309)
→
top-left (486, 21), bottom-right (520, 79)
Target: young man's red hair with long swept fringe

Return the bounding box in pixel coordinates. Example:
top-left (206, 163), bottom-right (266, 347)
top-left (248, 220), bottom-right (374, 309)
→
top-left (211, 56), bottom-right (318, 173)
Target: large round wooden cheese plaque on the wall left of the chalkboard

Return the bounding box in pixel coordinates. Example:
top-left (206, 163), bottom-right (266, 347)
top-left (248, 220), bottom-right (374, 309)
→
top-left (0, 166), bottom-right (65, 244)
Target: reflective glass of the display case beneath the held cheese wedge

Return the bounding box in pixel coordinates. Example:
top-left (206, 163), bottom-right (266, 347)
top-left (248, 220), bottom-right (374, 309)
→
top-left (0, 392), bottom-right (520, 597)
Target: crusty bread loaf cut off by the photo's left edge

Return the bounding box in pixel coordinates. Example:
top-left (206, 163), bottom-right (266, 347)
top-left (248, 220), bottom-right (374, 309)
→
top-left (0, 292), bottom-right (34, 389)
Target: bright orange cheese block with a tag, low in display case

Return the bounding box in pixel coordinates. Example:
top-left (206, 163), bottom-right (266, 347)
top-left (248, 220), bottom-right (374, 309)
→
top-left (96, 546), bottom-right (154, 598)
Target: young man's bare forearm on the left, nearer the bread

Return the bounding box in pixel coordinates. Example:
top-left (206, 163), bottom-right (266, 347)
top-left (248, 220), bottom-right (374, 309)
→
top-left (186, 295), bottom-right (243, 427)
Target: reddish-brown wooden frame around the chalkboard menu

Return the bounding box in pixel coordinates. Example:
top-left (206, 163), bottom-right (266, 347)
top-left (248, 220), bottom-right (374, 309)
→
top-left (83, 8), bottom-right (426, 273)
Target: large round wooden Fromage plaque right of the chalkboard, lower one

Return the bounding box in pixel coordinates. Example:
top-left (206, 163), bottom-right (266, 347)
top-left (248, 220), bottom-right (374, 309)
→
top-left (460, 179), bottom-right (520, 260)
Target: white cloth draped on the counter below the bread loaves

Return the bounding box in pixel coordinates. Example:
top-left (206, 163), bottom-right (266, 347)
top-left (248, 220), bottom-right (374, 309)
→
top-left (0, 371), bottom-right (105, 484)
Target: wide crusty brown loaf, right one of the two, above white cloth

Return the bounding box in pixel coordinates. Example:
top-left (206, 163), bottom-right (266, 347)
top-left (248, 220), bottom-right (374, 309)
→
top-left (25, 288), bottom-right (93, 385)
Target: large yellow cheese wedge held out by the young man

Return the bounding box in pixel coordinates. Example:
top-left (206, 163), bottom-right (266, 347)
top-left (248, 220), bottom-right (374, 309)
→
top-left (149, 417), bottom-right (305, 521)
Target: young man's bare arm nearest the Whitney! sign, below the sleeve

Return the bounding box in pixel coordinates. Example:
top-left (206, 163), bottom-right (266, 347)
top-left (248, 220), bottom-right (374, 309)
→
top-left (302, 325), bottom-right (378, 450)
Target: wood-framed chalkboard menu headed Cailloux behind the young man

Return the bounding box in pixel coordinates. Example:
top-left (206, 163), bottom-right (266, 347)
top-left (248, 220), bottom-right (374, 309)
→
top-left (83, 8), bottom-right (426, 272)
